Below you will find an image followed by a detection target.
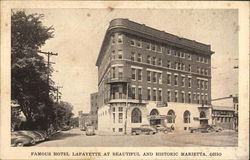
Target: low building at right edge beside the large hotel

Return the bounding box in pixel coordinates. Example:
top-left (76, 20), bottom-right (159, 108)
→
top-left (212, 95), bottom-right (239, 130)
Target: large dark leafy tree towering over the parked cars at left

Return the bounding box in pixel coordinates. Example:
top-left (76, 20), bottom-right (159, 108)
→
top-left (11, 11), bottom-right (55, 129)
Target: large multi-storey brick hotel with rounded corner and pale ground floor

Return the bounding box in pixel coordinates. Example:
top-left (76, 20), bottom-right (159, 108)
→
top-left (96, 19), bottom-right (213, 134)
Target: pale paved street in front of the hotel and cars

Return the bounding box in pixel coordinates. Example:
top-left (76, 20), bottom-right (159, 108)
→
top-left (33, 128), bottom-right (238, 147)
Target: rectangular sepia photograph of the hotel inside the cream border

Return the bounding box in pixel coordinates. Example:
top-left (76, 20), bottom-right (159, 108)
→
top-left (11, 8), bottom-right (239, 147)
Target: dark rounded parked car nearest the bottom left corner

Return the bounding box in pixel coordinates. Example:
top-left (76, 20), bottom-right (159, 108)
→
top-left (11, 132), bottom-right (36, 147)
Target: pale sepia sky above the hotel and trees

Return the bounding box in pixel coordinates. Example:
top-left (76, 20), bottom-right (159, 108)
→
top-left (24, 8), bottom-right (239, 115)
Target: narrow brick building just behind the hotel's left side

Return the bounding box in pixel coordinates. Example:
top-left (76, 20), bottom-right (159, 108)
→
top-left (90, 92), bottom-right (98, 129)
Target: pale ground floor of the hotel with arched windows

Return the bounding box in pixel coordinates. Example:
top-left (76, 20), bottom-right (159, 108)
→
top-left (98, 102), bottom-right (212, 135)
